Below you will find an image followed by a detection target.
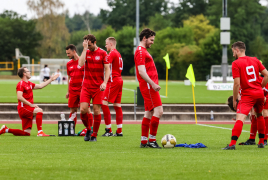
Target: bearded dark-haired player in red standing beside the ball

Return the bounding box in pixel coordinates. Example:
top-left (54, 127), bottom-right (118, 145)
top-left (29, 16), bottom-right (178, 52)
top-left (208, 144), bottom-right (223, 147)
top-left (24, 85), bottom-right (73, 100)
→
top-left (134, 29), bottom-right (163, 148)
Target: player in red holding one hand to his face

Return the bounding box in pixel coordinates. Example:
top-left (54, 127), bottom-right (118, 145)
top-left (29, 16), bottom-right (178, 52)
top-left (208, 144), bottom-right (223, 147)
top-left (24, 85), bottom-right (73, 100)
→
top-left (78, 34), bottom-right (110, 141)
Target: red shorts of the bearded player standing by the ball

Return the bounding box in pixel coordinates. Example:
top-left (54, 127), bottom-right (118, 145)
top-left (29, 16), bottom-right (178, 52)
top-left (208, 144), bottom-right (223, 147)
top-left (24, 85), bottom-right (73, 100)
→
top-left (141, 88), bottom-right (162, 111)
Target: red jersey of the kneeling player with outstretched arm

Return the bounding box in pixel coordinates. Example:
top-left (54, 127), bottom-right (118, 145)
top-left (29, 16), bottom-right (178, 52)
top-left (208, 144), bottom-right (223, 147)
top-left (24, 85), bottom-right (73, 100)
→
top-left (16, 80), bottom-right (35, 109)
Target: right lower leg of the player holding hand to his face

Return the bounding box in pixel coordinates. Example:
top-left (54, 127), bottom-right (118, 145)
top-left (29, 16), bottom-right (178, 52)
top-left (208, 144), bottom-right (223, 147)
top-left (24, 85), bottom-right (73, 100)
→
top-left (90, 104), bottom-right (101, 141)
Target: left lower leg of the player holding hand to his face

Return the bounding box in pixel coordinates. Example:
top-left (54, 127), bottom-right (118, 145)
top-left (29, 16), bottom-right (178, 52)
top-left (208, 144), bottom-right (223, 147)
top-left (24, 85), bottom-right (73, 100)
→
top-left (80, 102), bottom-right (91, 141)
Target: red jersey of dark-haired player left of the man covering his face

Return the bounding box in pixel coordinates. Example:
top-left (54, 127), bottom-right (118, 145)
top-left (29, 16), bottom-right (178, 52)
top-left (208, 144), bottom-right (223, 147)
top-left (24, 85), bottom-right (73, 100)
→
top-left (66, 59), bottom-right (84, 93)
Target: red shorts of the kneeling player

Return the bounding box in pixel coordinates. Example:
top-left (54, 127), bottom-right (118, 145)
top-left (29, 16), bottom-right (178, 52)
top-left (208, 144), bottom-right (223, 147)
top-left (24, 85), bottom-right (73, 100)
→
top-left (18, 106), bottom-right (35, 130)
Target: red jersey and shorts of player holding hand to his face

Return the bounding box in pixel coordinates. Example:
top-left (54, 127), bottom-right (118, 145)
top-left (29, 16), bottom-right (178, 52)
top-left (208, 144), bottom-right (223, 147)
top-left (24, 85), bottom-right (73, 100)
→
top-left (80, 48), bottom-right (109, 104)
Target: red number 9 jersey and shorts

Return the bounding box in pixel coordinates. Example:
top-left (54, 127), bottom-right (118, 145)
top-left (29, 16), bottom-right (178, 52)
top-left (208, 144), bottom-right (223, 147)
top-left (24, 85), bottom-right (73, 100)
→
top-left (232, 56), bottom-right (265, 115)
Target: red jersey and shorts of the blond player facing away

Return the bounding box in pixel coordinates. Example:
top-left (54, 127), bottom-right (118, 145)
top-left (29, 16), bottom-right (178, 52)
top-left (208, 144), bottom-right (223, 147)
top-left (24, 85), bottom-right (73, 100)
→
top-left (103, 49), bottom-right (123, 103)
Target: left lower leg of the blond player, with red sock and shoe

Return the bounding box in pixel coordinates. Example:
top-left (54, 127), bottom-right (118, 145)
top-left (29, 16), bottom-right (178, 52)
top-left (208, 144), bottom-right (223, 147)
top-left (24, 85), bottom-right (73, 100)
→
top-left (101, 101), bottom-right (113, 137)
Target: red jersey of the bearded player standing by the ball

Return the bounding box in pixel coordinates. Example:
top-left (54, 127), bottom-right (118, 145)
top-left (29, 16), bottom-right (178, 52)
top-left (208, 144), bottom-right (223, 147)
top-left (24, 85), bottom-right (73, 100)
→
top-left (134, 46), bottom-right (158, 91)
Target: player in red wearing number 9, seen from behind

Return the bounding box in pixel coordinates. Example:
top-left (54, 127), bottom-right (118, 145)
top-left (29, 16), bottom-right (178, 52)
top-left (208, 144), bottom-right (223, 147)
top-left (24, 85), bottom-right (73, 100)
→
top-left (223, 41), bottom-right (268, 150)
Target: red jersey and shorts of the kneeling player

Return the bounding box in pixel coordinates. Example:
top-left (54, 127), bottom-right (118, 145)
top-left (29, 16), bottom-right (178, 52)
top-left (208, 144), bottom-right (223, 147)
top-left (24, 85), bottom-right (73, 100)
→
top-left (16, 80), bottom-right (35, 130)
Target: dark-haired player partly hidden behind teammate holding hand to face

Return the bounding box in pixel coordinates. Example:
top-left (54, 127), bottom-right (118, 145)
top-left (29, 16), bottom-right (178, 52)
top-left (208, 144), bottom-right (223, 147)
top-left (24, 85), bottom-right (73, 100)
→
top-left (65, 44), bottom-right (93, 129)
